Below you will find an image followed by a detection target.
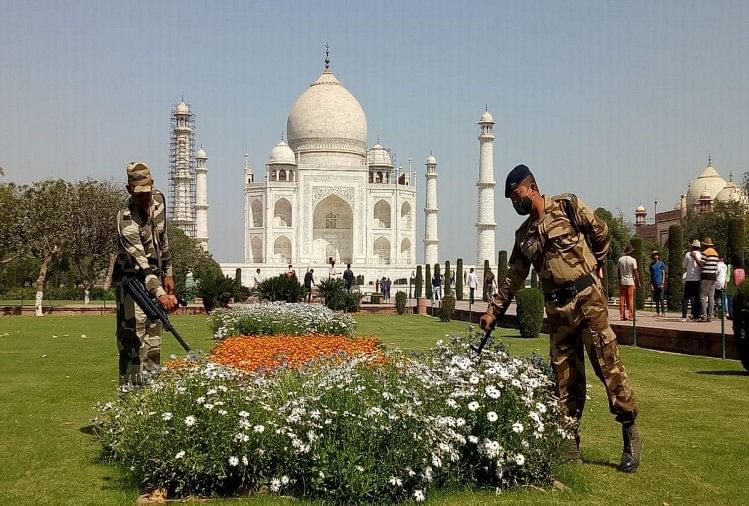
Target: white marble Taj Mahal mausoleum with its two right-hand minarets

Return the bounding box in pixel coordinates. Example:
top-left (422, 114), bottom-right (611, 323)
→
top-left (221, 54), bottom-right (496, 286)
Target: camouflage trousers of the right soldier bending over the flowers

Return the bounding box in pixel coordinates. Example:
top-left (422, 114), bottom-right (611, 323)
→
top-left (546, 281), bottom-right (638, 423)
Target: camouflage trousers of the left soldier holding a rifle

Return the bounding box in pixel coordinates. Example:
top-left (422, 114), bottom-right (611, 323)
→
top-left (116, 286), bottom-right (161, 385)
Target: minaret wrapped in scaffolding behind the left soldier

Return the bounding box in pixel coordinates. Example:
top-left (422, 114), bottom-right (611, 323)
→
top-left (169, 100), bottom-right (195, 238)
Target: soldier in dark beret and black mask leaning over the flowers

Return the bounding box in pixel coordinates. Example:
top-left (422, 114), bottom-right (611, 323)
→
top-left (481, 165), bottom-right (642, 473)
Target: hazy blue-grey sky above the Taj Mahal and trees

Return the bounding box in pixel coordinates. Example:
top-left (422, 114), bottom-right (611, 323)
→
top-left (0, 0), bottom-right (749, 263)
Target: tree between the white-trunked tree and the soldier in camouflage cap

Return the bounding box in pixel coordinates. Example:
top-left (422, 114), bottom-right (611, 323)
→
top-left (69, 179), bottom-right (126, 289)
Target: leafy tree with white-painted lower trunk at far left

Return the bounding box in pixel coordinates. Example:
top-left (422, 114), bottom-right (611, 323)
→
top-left (14, 179), bottom-right (74, 316)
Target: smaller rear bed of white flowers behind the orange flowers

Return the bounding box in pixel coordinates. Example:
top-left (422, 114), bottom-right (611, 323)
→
top-left (208, 302), bottom-right (356, 340)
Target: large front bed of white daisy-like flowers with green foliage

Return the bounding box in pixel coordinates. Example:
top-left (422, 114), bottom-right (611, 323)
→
top-left (95, 337), bottom-right (569, 504)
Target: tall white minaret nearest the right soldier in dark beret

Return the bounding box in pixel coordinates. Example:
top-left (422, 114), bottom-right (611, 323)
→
top-left (476, 110), bottom-right (497, 268)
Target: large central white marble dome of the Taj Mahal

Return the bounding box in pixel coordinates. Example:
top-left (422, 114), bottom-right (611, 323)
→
top-left (286, 69), bottom-right (367, 157)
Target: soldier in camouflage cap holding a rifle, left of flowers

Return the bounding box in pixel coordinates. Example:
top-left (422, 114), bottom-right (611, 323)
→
top-left (113, 162), bottom-right (177, 385)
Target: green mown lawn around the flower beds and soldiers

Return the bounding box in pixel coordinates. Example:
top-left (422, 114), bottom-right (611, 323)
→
top-left (0, 316), bottom-right (749, 505)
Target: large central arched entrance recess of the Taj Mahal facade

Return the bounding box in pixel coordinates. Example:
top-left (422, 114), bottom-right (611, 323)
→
top-left (312, 195), bottom-right (354, 263)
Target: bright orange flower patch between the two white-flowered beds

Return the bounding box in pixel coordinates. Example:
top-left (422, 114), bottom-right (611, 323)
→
top-left (210, 334), bottom-right (383, 372)
